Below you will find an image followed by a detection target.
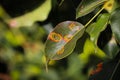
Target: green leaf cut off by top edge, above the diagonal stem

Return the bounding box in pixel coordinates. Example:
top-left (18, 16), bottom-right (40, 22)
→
top-left (76, 0), bottom-right (107, 18)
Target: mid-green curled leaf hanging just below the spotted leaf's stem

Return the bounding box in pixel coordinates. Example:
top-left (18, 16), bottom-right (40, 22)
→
top-left (86, 13), bottom-right (110, 43)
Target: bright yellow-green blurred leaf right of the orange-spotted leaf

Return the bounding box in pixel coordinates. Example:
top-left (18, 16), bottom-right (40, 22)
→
top-left (79, 39), bottom-right (106, 65)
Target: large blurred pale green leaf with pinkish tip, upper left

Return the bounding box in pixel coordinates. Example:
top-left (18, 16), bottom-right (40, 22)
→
top-left (6, 0), bottom-right (51, 27)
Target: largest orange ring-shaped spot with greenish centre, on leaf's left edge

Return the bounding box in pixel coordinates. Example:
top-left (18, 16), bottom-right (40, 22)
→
top-left (48, 32), bottom-right (62, 42)
